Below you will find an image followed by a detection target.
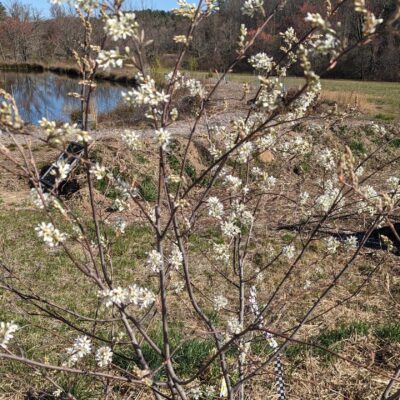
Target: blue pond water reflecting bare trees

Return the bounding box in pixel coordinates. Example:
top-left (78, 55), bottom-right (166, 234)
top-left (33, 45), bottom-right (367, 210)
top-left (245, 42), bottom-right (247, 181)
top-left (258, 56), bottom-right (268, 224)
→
top-left (0, 71), bottom-right (123, 125)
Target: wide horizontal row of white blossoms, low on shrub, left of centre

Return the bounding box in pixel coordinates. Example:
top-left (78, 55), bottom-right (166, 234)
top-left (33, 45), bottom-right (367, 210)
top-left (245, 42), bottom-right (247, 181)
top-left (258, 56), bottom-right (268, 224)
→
top-left (99, 284), bottom-right (155, 309)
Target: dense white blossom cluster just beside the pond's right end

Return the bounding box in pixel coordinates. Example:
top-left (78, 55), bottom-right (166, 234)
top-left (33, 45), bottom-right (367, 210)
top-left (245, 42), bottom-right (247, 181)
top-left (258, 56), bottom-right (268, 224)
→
top-left (122, 74), bottom-right (169, 107)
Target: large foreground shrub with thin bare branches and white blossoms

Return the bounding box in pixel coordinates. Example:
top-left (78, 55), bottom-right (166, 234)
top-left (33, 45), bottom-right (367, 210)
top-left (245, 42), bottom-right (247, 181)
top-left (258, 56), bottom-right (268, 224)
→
top-left (0, 0), bottom-right (400, 400)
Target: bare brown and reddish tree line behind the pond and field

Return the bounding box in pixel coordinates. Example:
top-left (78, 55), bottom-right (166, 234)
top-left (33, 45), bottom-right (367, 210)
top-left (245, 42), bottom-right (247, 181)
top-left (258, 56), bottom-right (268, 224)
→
top-left (0, 0), bottom-right (400, 81)
